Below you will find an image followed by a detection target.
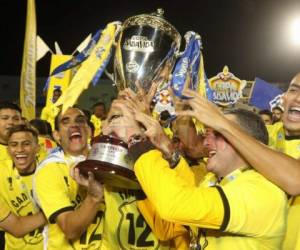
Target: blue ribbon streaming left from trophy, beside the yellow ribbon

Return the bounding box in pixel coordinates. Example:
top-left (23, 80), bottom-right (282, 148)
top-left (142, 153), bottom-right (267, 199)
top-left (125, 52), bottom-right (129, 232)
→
top-left (43, 29), bottom-right (102, 91)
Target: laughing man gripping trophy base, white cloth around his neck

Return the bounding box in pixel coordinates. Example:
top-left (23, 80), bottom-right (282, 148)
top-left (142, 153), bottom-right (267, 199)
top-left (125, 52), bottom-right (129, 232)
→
top-left (34, 108), bottom-right (103, 250)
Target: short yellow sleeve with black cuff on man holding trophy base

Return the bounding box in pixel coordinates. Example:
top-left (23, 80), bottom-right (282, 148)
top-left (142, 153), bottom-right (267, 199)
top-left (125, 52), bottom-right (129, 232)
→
top-left (33, 163), bottom-right (74, 223)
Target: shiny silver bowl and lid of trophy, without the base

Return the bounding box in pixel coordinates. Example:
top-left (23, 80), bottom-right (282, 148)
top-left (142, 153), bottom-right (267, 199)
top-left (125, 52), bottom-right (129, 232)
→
top-left (114, 9), bottom-right (181, 91)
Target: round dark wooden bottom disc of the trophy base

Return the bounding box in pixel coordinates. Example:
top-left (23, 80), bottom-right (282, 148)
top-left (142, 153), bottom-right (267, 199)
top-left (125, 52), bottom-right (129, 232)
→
top-left (76, 160), bottom-right (141, 190)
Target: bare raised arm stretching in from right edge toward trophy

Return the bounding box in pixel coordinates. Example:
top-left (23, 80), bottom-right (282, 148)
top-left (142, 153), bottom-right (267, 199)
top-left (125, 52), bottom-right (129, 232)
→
top-left (178, 90), bottom-right (300, 195)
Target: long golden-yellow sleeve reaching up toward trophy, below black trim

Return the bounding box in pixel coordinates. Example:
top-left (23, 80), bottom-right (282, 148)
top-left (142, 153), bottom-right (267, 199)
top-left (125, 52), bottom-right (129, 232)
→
top-left (134, 150), bottom-right (229, 229)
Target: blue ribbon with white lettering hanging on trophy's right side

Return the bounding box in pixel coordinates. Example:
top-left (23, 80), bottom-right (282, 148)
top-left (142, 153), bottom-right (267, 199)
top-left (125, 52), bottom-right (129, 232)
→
top-left (171, 31), bottom-right (201, 99)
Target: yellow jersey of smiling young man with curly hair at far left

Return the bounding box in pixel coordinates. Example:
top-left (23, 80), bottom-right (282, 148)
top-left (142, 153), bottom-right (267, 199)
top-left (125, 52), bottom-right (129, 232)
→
top-left (0, 161), bottom-right (43, 250)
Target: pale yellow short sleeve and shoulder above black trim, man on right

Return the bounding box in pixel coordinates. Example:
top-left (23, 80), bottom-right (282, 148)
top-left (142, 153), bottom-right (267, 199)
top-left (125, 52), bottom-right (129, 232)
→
top-left (223, 170), bottom-right (287, 236)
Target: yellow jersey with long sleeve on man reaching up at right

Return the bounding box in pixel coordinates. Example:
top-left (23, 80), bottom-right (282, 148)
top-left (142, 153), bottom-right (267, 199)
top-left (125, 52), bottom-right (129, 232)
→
top-left (134, 150), bottom-right (287, 250)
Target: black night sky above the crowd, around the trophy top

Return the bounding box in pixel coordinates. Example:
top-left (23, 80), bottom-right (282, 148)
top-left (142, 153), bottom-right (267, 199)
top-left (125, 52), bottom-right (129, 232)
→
top-left (0, 0), bottom-right (300, 82)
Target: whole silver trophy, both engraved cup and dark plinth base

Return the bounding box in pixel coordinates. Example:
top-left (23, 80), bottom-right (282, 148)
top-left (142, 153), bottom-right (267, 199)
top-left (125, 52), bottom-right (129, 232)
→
top-left (77, 9), bottom-right (181, 189)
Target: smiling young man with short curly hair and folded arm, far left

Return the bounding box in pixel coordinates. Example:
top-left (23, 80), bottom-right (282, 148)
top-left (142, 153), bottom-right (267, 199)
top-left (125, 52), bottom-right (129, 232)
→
top-left (0, 124), bottom-right (46, 250)
